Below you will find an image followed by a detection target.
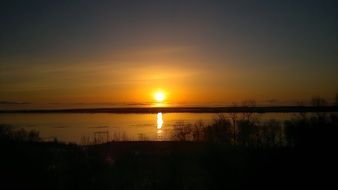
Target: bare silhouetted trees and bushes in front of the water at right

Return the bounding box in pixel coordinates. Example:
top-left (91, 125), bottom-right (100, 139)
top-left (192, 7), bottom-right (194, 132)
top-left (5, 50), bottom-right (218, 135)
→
top-left (172, 96), bottom-right (338, 147)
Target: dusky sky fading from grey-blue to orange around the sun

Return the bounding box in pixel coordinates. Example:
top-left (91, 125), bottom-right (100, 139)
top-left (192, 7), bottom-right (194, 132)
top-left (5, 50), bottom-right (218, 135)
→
top-left (0, 0), bottom-right (338, 108)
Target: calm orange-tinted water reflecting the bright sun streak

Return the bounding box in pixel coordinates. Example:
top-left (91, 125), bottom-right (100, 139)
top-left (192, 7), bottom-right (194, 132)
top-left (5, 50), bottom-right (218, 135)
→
top-left (0, 113), bottom-right (292, 143)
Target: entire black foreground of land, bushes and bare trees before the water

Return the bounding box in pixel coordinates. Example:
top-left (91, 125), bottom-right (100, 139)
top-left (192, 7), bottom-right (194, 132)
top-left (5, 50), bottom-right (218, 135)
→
top-left (0, 109), bottom-right (338, 189)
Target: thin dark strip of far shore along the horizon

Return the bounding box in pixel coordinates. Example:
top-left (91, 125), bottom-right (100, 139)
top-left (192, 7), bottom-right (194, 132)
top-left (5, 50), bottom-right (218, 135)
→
top-left (0, 106), bottom-right (338, 114)
